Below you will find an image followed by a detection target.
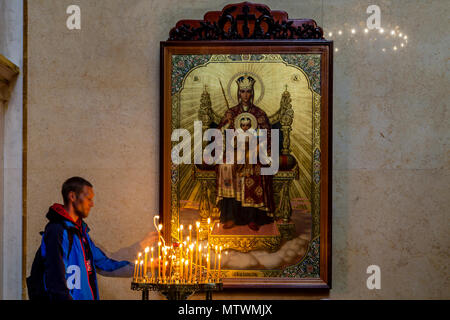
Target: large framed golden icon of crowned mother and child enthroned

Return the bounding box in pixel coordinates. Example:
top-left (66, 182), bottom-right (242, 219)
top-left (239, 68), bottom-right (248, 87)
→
top-left (160, 3), bottom-right (333, 288)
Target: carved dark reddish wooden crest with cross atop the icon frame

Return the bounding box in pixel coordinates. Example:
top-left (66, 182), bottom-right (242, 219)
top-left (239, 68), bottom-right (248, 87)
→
top-left (168, 2), bottom-right (323, 41)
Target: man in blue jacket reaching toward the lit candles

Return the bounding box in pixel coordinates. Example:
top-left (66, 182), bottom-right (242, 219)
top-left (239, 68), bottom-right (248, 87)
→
top-left (38, 177), bottom-right (130, 300)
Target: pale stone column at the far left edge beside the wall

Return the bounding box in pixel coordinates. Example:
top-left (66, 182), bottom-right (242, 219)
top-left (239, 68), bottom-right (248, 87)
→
top-left (0, 0), bottom-right (23, 299)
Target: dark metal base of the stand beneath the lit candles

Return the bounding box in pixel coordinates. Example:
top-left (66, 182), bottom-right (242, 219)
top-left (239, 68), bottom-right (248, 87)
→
top-left (131, 282), bottom-right (223, 300)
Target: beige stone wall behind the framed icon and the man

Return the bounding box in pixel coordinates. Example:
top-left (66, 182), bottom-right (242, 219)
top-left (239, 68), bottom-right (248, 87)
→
top-left (27, 0), bottom-right (450, 299)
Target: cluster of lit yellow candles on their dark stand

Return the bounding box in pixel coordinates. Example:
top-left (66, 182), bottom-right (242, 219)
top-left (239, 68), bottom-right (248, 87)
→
top-left (131, 216), bottom-right (226, 300)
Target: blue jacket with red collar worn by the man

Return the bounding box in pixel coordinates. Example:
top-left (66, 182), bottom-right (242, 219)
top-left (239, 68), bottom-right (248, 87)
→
top-left (41, 204), bottom-right (130, 300)
